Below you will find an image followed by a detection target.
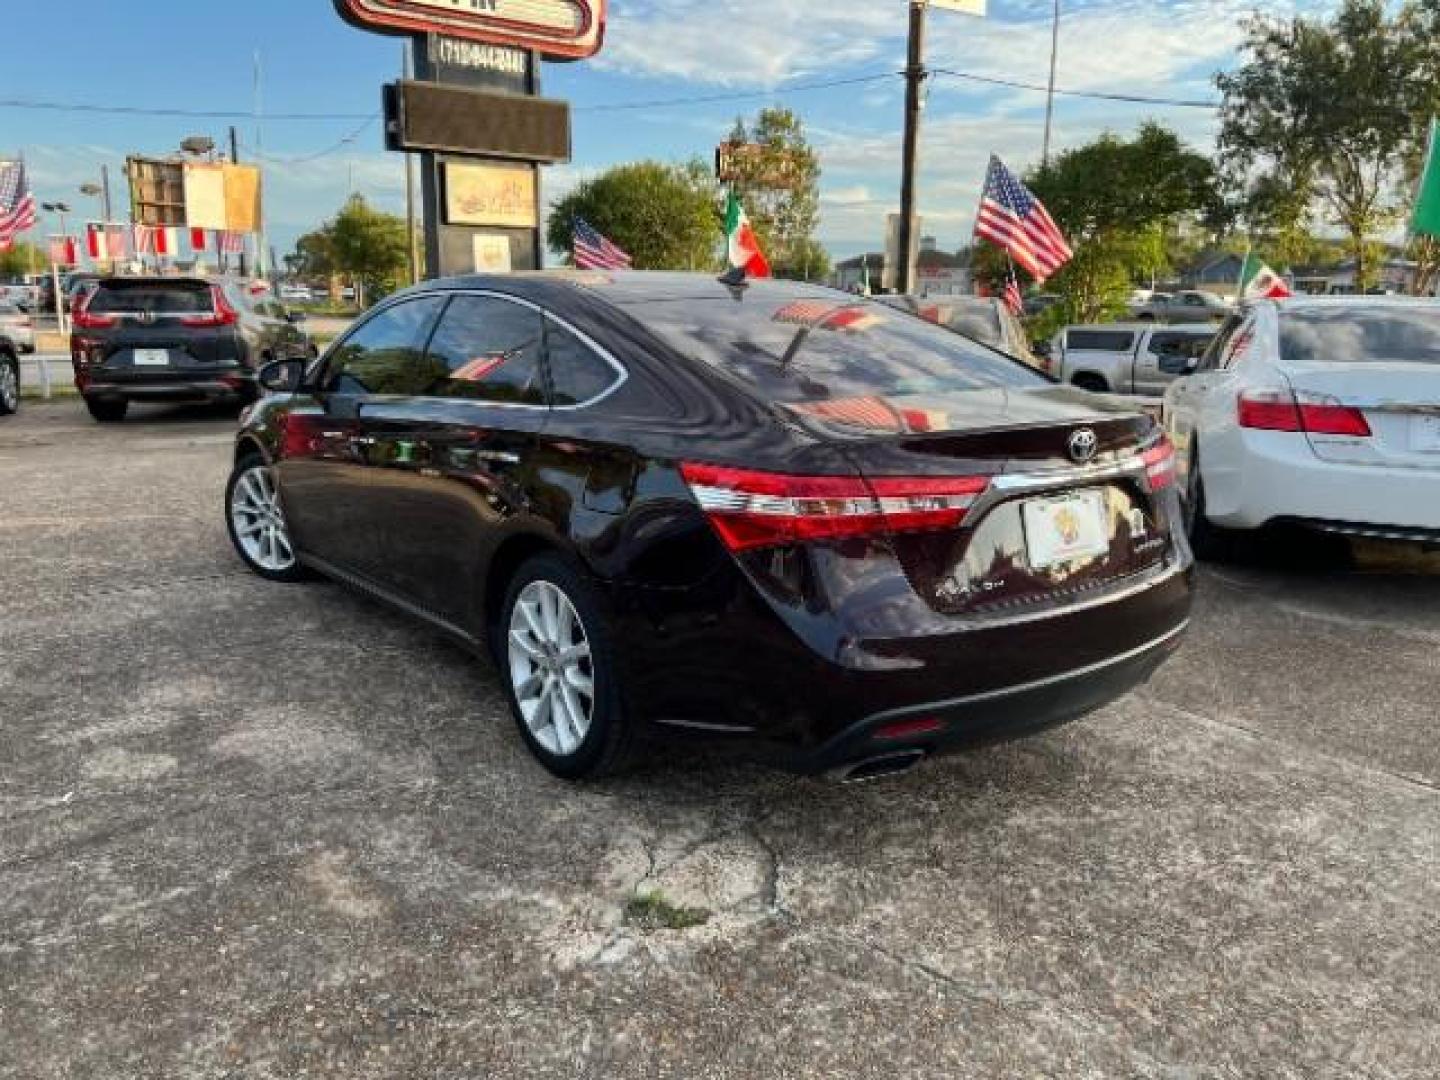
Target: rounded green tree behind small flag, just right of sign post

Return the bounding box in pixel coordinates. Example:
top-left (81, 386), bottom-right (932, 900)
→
top-left (546, 161), bottom-right (720, 271)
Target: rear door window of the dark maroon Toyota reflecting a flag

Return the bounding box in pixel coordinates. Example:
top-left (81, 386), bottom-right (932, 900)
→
top-left (419, 295), bottom-right (546, 405)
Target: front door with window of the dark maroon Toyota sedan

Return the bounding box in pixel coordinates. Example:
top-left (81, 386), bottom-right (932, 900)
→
top-left (276, 295), bottom-right (445, 579)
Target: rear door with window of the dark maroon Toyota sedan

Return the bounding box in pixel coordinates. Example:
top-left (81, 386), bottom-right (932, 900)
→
top-left (359, 292), bottom-right (549, 631)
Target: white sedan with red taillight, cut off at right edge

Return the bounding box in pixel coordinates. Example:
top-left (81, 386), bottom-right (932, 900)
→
top-left (1162, 297), bottom-right (1440, 556)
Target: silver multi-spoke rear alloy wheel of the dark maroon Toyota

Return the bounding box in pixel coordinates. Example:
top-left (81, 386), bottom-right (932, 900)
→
top-left (508, 580), bottom-right (595, 757)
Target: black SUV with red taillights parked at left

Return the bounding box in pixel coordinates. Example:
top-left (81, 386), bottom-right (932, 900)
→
top-left (71, 278), bottom-right (312, 422)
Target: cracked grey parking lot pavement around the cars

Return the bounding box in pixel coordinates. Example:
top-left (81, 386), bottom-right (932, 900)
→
top-left (0, 399), bottom-right (1440, 1080)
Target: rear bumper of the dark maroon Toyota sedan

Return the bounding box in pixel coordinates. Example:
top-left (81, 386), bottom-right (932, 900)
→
top-left (619, 552), bottom-right (1192, 773)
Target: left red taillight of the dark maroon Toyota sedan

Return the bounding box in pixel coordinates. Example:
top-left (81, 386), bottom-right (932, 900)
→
top-left (680, 462), bottom-right (989, 552)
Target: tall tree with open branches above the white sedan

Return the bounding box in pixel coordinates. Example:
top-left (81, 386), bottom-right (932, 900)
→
top-left (1217, 0), bottom-right (1436, 288)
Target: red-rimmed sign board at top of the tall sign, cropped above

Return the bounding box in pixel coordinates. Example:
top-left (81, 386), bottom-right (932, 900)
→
top-left (336, 0), bottom-right (605, 60)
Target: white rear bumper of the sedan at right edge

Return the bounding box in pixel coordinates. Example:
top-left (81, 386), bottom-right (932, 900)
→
top-left (1201, 432), bottom-right (1440, 530)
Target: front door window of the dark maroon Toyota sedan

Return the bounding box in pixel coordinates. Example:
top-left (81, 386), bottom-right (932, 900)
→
top-left (325, 297), bottom-right (445, 396)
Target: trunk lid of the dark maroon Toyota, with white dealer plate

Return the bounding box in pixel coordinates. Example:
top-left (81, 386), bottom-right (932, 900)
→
top-left (785, 387), bottom-right (1171, 615)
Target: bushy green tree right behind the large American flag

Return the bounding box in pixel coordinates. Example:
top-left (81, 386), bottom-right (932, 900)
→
top-left (1008, 122), bottom-right (1223, 321)
